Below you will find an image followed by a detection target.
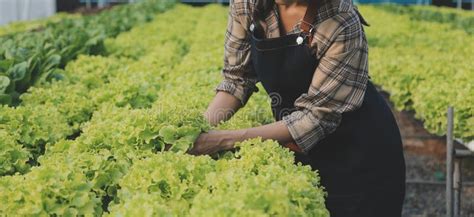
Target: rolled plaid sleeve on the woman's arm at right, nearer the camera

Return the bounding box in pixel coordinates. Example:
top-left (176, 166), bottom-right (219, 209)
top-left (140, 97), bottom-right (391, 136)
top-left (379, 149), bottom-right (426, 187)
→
top-left (283, 13), bottom-right (368, 152)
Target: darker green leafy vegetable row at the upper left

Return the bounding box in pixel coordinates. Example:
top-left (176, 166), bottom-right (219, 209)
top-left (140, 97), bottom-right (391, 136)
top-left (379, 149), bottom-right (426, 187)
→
top-left (0, 0), bottom-right (174, 105)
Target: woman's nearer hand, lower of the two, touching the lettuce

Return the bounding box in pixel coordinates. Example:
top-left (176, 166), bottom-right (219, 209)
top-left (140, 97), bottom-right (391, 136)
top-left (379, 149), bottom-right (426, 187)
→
top-left (188, 130), bottom-right (238, 155)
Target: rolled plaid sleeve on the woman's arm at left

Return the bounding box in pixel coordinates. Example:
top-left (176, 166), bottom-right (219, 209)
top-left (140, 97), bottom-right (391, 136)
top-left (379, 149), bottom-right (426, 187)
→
top-left (216, 0), bottom-right (257, 105)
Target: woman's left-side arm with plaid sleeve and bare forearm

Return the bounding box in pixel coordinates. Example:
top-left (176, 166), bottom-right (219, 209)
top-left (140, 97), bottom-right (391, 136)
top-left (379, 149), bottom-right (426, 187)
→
top-left (204, 0), bottom-right (257, 126)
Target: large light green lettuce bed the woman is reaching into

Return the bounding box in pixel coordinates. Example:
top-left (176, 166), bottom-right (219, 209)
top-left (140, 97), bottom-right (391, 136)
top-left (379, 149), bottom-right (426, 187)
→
top-left (0, 5), bottom-right (329, 216)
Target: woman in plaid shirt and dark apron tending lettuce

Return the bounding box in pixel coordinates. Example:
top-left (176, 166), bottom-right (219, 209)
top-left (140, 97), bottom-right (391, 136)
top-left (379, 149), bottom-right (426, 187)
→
top-left (189, 0), bottom-right (405, 217)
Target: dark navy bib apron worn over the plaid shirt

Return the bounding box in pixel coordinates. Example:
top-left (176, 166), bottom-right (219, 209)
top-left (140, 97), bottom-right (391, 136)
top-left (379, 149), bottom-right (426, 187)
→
top-left (250, 0), bottom-right (405, 217)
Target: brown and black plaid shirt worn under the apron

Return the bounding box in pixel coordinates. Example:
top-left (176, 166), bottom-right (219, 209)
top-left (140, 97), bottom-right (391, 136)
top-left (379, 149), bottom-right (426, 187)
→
top-left (216, 0), bottom-right (368, 152)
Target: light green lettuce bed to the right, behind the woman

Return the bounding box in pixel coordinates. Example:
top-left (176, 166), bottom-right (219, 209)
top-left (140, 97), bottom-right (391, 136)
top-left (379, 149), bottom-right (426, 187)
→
top-left (359, 6), bottom-right (474, 142)
